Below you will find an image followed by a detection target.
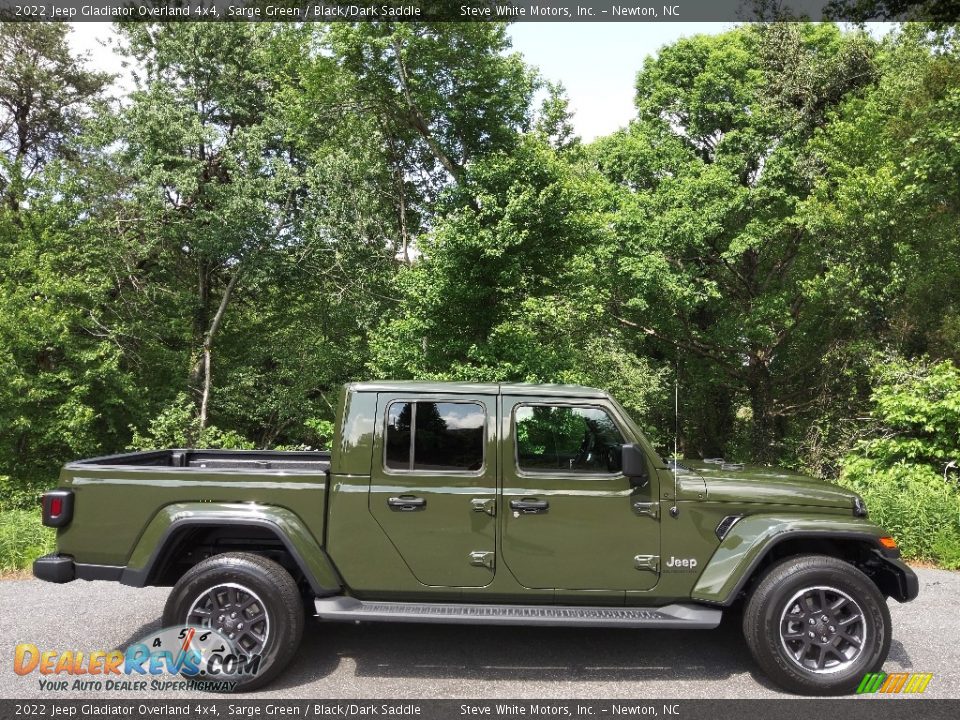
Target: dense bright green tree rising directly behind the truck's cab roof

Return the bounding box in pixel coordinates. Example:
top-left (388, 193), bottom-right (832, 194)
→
top-left (372, 133), bottom-right (662, 434)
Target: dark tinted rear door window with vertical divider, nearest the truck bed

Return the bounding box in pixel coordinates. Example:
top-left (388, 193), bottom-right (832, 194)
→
top-left (384, 402), bottom-right (486, 472)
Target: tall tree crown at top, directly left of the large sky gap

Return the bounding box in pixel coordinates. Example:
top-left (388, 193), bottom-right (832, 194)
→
top-left (324, 23), bottom-right (536, 262)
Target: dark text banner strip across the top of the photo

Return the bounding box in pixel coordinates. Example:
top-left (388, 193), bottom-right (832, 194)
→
top-left (0, 0), bottom-right (960, 23)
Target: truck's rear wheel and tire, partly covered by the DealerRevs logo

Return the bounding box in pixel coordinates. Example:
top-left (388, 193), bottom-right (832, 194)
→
top-left (163, 552), bottom-right (304, 692)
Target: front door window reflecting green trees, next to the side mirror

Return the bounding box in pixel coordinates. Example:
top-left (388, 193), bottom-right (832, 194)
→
top-left (513, 405), bottom-right (623, 473)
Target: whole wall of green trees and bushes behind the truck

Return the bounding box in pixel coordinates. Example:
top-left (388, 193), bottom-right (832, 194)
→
top-left (0, 23), bottom-right (960, 564)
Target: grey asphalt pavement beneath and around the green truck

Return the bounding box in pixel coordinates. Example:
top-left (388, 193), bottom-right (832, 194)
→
top-left (0, 568), bottom-right (960, 700)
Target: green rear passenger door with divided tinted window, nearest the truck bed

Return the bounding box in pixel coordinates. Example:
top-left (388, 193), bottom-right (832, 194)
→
top-left (369, 393), bottom-right (497, 587)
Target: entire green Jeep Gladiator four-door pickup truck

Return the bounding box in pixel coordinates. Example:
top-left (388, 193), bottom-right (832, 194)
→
top-left (34, 382), bottom-right (918, 694)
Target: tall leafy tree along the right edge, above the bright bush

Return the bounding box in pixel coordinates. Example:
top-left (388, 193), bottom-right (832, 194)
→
top-left (800, 25), bottom-right (960, 474)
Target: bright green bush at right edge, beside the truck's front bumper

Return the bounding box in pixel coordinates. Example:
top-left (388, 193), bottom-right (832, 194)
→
top-left (840, 362), bottom-right (960, 568)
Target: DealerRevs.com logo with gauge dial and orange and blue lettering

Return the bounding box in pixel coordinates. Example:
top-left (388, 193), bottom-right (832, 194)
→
top-left (13, 626), bottom-right (261, 692)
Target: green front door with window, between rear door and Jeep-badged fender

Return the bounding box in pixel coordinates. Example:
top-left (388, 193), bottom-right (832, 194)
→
top-left (501, 396), bottom-right (660, 591)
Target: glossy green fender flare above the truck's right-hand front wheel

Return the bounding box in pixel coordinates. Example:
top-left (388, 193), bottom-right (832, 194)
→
top-left (691, 513), bottom-right (884, 605)
